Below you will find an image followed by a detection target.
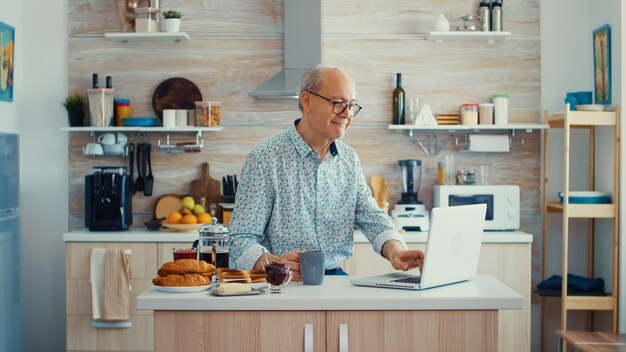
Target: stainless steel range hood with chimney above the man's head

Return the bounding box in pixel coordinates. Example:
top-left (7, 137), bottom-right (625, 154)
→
top-left (248, 0), bottom-right (322, 98)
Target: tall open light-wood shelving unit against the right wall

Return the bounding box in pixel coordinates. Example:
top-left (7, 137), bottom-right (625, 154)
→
top-left (541, 104), bottom-right (620, 350)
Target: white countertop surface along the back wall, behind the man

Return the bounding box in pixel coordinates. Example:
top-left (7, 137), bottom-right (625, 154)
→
top-left (63, 229), bottom-right (533, 243)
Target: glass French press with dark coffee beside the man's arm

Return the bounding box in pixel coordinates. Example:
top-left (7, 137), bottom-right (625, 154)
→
top-left (198, 217), bottom-right (229, 268)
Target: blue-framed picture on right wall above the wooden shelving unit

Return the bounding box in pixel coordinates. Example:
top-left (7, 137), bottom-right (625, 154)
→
top-left (593, 24), bottom-right (611, 104)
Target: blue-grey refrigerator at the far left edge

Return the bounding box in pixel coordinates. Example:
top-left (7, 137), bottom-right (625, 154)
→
top-left (0, 133), bottom-right (22, 352)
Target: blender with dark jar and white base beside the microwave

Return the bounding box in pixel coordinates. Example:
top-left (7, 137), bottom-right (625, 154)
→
top-left (391, 160), bottom-right (430, 231)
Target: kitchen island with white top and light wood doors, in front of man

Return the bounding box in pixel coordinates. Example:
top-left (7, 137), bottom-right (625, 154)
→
top-left (137, 275), bottom-right (523, 351)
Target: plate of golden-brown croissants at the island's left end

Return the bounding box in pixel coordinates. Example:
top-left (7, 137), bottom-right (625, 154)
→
top-left (152, 259), bottom-right (215, 292)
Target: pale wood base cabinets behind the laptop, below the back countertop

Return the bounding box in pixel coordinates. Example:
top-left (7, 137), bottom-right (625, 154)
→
top-left (344, 238), bottom-right (532, 352)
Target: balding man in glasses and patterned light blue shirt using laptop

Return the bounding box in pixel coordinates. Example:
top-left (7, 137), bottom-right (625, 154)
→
top-left (230, 66), bottom-right (424, 280)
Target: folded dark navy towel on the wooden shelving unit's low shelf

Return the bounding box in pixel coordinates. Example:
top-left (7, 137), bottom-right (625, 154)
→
top-left (537, 274), bottom-right (606, 296)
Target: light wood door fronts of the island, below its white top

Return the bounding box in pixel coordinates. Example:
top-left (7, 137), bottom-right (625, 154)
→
top-left (155, 310), bottom-right (498, 352)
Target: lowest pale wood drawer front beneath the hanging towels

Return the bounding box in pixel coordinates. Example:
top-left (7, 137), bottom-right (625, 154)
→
top-left (66, 314), bottom-right (154, 352)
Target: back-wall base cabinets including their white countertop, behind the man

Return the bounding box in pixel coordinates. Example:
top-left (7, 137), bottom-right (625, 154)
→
top-left (63, 228), bottom-right (533, 352)
